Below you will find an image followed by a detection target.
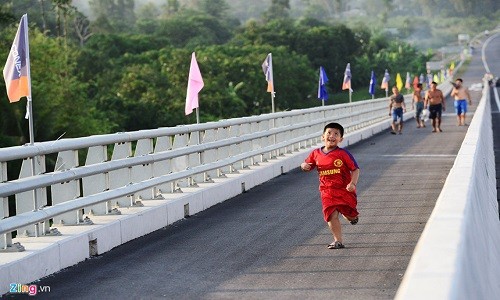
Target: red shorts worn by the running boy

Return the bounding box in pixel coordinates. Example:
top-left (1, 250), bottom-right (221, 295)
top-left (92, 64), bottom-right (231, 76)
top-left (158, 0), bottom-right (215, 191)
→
top-left (320, 189), bottom-right (359, 222)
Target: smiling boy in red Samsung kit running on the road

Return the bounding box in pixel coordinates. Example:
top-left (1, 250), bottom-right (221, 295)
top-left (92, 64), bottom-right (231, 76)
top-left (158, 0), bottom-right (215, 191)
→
top-left (300, 123), bottom-right (359, 249)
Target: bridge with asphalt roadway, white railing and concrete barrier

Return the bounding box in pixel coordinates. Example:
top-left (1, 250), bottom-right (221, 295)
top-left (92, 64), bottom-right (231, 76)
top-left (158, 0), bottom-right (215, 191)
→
top-left (0, 31), bottom-right (500, 299)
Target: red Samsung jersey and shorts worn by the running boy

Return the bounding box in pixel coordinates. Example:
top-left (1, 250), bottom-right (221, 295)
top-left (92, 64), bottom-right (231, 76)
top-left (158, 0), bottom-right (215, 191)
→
top-left (305, 147), bottom-right (359, 222)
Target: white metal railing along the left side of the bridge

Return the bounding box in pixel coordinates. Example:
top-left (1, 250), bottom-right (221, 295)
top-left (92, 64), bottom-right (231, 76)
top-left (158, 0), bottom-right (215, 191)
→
top-left (0, 96), bottom-right (402, 251)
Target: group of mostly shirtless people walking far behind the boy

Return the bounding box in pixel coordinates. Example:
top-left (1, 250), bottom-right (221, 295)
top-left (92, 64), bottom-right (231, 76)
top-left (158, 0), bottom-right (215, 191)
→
top-left (389, 78), bottom-right (472, 134)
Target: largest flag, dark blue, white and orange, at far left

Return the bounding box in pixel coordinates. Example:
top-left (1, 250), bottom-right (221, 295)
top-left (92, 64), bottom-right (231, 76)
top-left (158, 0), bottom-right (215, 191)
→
top-left (3, 14), bottom-right (31, 103)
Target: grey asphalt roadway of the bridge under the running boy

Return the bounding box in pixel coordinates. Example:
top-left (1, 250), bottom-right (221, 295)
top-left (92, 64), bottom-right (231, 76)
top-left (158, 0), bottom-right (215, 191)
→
top-left (4, 56), bottom-right (484, 299)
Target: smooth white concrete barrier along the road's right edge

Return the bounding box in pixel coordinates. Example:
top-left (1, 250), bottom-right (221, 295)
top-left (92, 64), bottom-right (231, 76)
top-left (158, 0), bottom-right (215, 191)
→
top-left (396, 84), bottom-right (500, 299)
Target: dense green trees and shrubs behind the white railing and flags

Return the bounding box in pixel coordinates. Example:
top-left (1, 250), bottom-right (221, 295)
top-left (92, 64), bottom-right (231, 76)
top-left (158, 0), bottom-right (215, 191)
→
top-left (0, 0), bottom-right (498, 147)
